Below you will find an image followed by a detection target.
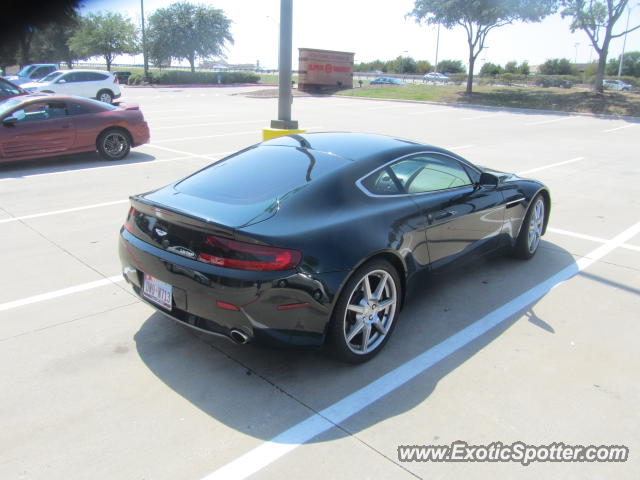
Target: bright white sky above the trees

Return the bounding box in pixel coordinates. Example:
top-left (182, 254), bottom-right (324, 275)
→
top-left (82, 0), bottom-right (640, 69)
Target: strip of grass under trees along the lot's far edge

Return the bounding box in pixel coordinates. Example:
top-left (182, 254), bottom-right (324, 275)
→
top-left (337, 85), bottom-right (640, 116)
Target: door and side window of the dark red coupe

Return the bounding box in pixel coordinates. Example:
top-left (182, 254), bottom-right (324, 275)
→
top-left (0, 100), bottom-right (75, 160)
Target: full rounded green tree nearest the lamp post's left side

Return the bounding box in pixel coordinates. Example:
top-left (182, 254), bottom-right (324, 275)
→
top-left (148, 2), bottom-right (233, 72)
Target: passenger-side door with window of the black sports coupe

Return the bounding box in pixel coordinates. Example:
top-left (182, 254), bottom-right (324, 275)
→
top-left (390, 152), bottom-right (504, 268)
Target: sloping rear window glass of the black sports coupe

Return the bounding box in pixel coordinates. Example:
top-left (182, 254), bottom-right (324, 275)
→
top-left (176, 146), bottom-right (349, 204)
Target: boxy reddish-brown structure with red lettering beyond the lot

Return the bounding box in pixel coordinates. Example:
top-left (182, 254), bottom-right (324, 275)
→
top-left (298, 48), bottom-right (354, 91)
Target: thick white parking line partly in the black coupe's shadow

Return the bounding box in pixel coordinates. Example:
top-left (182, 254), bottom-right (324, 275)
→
top-left (203, 223), bottom-right (640, 480)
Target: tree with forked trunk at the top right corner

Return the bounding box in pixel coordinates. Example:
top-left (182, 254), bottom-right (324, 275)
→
top-left (560, 0), bottom-right (640, 93)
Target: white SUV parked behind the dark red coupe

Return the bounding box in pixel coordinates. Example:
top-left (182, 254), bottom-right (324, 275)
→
top-left (22, 69), bottom-right (121, 103)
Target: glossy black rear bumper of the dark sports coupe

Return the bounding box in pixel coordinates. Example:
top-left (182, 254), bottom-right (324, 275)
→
top-left (119, 229), bottom-right (344, 346)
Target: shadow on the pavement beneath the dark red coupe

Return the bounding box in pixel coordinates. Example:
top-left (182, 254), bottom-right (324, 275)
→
top-left (0, 151), bottom-right (156, 179)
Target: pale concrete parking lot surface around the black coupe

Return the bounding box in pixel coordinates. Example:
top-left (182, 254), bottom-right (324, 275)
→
top-left (0, 87), bottom-right (640, 480)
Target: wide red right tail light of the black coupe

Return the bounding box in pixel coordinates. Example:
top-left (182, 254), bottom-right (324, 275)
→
top-left (198, 235), bottom-right (301, 271)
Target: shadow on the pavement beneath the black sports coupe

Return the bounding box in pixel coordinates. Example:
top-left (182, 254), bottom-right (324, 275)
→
top-left (135, 242), bottom-right (575, 442)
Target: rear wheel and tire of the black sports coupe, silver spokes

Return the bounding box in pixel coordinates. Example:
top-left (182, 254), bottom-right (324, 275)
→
top-left (327, 259), bottom-right (402, 364)
